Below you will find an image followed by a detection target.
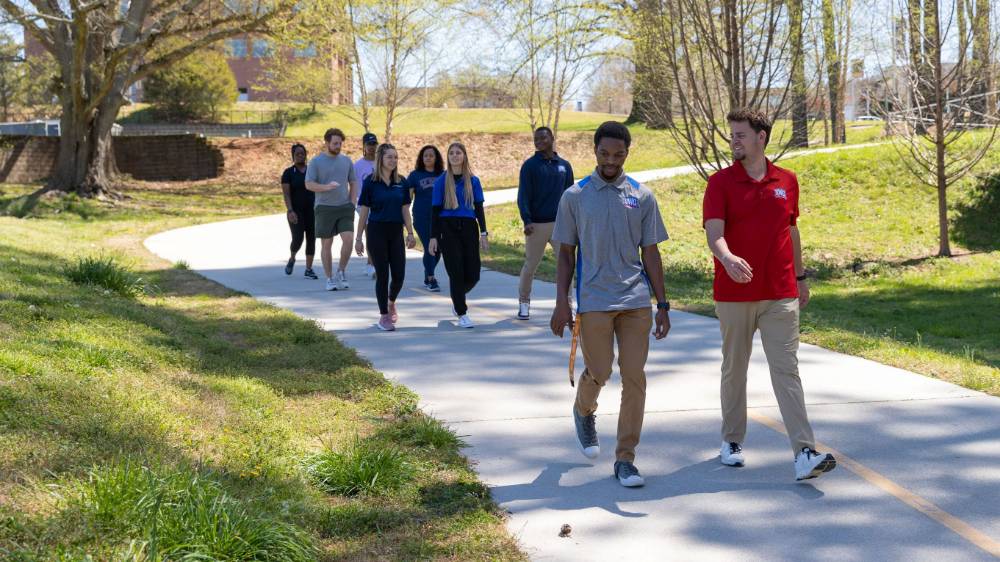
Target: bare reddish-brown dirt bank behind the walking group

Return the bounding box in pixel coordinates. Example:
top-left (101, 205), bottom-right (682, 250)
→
top-left (213, 132), bottom-right (593, 189)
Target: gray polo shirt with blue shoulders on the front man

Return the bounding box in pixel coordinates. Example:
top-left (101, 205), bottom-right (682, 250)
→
top-left (552, 171), bottom-right (667, 313)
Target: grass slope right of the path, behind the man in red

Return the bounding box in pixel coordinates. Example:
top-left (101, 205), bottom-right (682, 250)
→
top-left (485, 141), bottom-right (1000, 396)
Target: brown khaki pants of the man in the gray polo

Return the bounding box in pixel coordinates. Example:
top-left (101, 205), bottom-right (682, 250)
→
top-left (576, 308), bottom-right (653, 461)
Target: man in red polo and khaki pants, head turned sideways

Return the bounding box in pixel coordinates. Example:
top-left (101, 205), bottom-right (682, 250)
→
top-left (702, 109), bottom-right (837, 480)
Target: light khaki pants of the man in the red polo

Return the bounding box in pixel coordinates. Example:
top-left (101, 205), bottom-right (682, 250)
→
top-left (715, 298), bottom-right (816, 454)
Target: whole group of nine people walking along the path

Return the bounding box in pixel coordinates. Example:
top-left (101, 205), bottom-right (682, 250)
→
top-left (282, 109), bottom-right (836, 487)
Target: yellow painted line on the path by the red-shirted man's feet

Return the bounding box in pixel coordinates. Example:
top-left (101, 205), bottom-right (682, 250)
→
top-left (747, 410), bottom-right (1000, 558)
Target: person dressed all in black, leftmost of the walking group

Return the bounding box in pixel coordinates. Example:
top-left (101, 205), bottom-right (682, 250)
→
top-left (281, 143), bottom-right (319, 279)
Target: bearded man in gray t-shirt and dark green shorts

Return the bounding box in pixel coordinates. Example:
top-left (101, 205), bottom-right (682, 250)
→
top-left (306, 129), bottom-right (358, 291)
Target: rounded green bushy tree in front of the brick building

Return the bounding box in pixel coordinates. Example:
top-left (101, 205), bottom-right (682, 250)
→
top-left (143, 49), bottom-right (239, 121)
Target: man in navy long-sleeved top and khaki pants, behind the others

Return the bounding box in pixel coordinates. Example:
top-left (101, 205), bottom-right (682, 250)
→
top-left (517, 127), bottom-right (574, 320)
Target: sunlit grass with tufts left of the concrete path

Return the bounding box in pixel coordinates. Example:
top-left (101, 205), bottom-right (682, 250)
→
top-left (0, 185), bottom-right (524, 561)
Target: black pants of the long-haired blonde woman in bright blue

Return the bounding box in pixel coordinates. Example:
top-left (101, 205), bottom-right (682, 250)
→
top-left (438, 217), bottom-right (480, 316)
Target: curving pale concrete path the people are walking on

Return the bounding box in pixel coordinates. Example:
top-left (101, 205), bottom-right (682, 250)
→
top-left (146, 199), bottom-right (1000, 562)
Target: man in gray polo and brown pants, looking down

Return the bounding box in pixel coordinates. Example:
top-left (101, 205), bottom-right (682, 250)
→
top-left (551, 121), bottom-right (670, 487)
